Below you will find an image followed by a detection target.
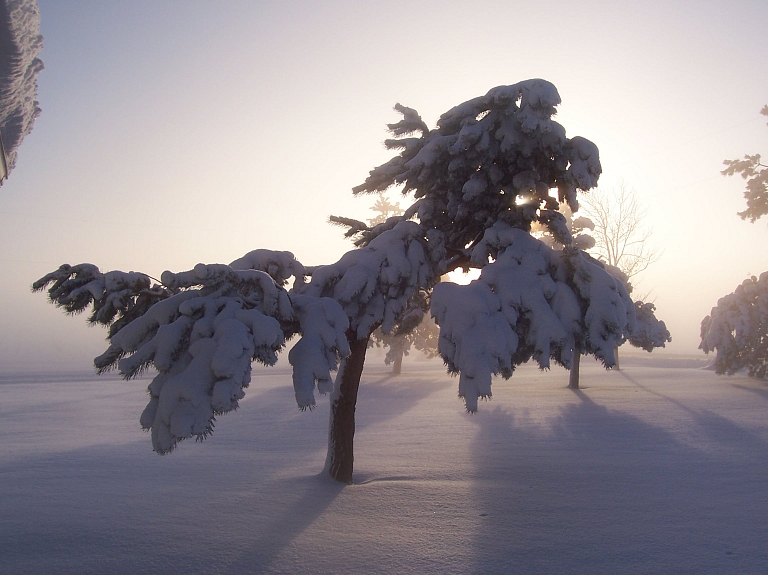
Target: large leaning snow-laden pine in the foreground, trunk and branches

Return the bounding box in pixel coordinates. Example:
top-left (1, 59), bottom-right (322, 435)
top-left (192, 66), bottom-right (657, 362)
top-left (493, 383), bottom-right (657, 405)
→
top-left (33, 80), bottom-right (668, 482)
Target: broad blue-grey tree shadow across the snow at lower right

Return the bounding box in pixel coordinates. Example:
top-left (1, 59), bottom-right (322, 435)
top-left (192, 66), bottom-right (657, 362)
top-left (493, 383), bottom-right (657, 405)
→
top-left (464, 384), bottom-right (768, 574)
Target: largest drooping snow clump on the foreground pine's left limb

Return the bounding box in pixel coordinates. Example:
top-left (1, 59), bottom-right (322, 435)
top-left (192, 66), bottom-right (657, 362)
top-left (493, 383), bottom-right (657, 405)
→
top-left (134, 288), bottom-right (287, 453)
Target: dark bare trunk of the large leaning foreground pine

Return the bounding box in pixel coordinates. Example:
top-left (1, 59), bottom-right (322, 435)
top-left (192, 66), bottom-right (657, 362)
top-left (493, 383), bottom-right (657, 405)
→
top-left (325, 334), bottom-right (368, 483)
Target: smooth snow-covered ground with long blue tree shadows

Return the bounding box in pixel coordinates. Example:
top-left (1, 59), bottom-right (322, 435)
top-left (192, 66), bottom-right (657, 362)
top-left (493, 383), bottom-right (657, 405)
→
top-left (0, 356), bottom-right (768, 575)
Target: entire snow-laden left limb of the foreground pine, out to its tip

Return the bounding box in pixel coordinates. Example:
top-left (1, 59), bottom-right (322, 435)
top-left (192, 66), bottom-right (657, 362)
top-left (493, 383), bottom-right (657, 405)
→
top-left (33, 250), bottom-right (356, 453)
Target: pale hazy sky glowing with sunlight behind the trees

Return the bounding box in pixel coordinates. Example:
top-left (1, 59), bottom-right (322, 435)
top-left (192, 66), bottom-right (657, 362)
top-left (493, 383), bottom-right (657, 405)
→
top-left (0, 0), bottom-right (768, 369)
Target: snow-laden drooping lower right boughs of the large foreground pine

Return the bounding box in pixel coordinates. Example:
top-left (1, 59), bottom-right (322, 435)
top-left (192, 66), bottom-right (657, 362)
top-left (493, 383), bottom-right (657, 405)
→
top-left (431, 222), bottom-right (669, 411)
